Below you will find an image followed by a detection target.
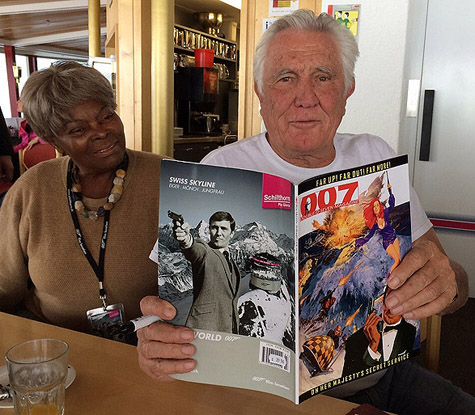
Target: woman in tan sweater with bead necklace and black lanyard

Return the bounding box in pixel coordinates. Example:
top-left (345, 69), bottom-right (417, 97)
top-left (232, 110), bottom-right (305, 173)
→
top-left (0, 62), bottom-right (162, 342)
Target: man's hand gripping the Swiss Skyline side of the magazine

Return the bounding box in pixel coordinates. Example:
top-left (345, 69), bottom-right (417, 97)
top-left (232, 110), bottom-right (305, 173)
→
top-left (137, 296), bottom-right (196, 382)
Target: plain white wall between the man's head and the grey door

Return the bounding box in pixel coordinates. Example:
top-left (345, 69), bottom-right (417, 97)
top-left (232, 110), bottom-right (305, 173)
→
top-left (322, 0), bottom-right (409, 151)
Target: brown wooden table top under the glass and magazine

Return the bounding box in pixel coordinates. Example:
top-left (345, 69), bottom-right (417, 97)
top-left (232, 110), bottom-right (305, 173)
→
top-left (0, 313), bottom-right (364, 415)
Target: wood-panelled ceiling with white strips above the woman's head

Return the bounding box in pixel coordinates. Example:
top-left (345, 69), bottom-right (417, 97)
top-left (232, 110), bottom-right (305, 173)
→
top-left (0, 0), bottom-right (106, 59)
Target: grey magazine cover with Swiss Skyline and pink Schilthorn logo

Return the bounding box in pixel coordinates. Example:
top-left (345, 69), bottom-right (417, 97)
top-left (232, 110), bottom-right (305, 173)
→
top-left (155, 160), bottom-right (297, 401)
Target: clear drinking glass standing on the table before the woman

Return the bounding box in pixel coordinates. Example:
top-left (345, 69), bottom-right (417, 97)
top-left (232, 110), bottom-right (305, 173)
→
top-left (5, 339), bottom-right (69, 415)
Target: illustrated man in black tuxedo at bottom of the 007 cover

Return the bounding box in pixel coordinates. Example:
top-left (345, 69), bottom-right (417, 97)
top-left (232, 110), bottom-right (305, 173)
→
top-left (342, 288), bottom-right (416, 377)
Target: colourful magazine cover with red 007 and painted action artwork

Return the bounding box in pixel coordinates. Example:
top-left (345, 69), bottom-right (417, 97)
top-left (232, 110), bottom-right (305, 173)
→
top-left (296, 156), bottom-right (420, 402)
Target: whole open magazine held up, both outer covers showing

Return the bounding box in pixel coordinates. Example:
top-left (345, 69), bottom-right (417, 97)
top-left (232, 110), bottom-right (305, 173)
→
top-left (156, 156), bottom-right (420, 403)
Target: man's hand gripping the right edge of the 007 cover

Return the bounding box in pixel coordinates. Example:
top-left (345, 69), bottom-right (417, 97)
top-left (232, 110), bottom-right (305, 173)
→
top-left (386, 229), bottom-right (467, 319)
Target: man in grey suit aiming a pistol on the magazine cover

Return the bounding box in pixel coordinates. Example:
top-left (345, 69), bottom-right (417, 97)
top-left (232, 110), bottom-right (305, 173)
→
top-left (173, 212), bottom-right (241, 333)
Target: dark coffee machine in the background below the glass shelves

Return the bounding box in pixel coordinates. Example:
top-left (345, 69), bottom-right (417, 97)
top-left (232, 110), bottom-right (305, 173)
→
top-left (175, 67), bottom-right (221, 136)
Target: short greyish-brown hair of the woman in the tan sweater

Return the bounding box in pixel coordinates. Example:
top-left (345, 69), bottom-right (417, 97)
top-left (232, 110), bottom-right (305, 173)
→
top-left (21, 62), bottom-right (117, 141)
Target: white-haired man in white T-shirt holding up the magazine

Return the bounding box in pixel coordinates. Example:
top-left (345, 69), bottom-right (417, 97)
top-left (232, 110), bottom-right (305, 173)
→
top-left (138, 10), bottom-right (475, 415)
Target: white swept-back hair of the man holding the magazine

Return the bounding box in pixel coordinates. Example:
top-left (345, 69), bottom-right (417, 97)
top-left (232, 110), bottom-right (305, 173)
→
top-left (254, 9), bottom-right (359, 93)
